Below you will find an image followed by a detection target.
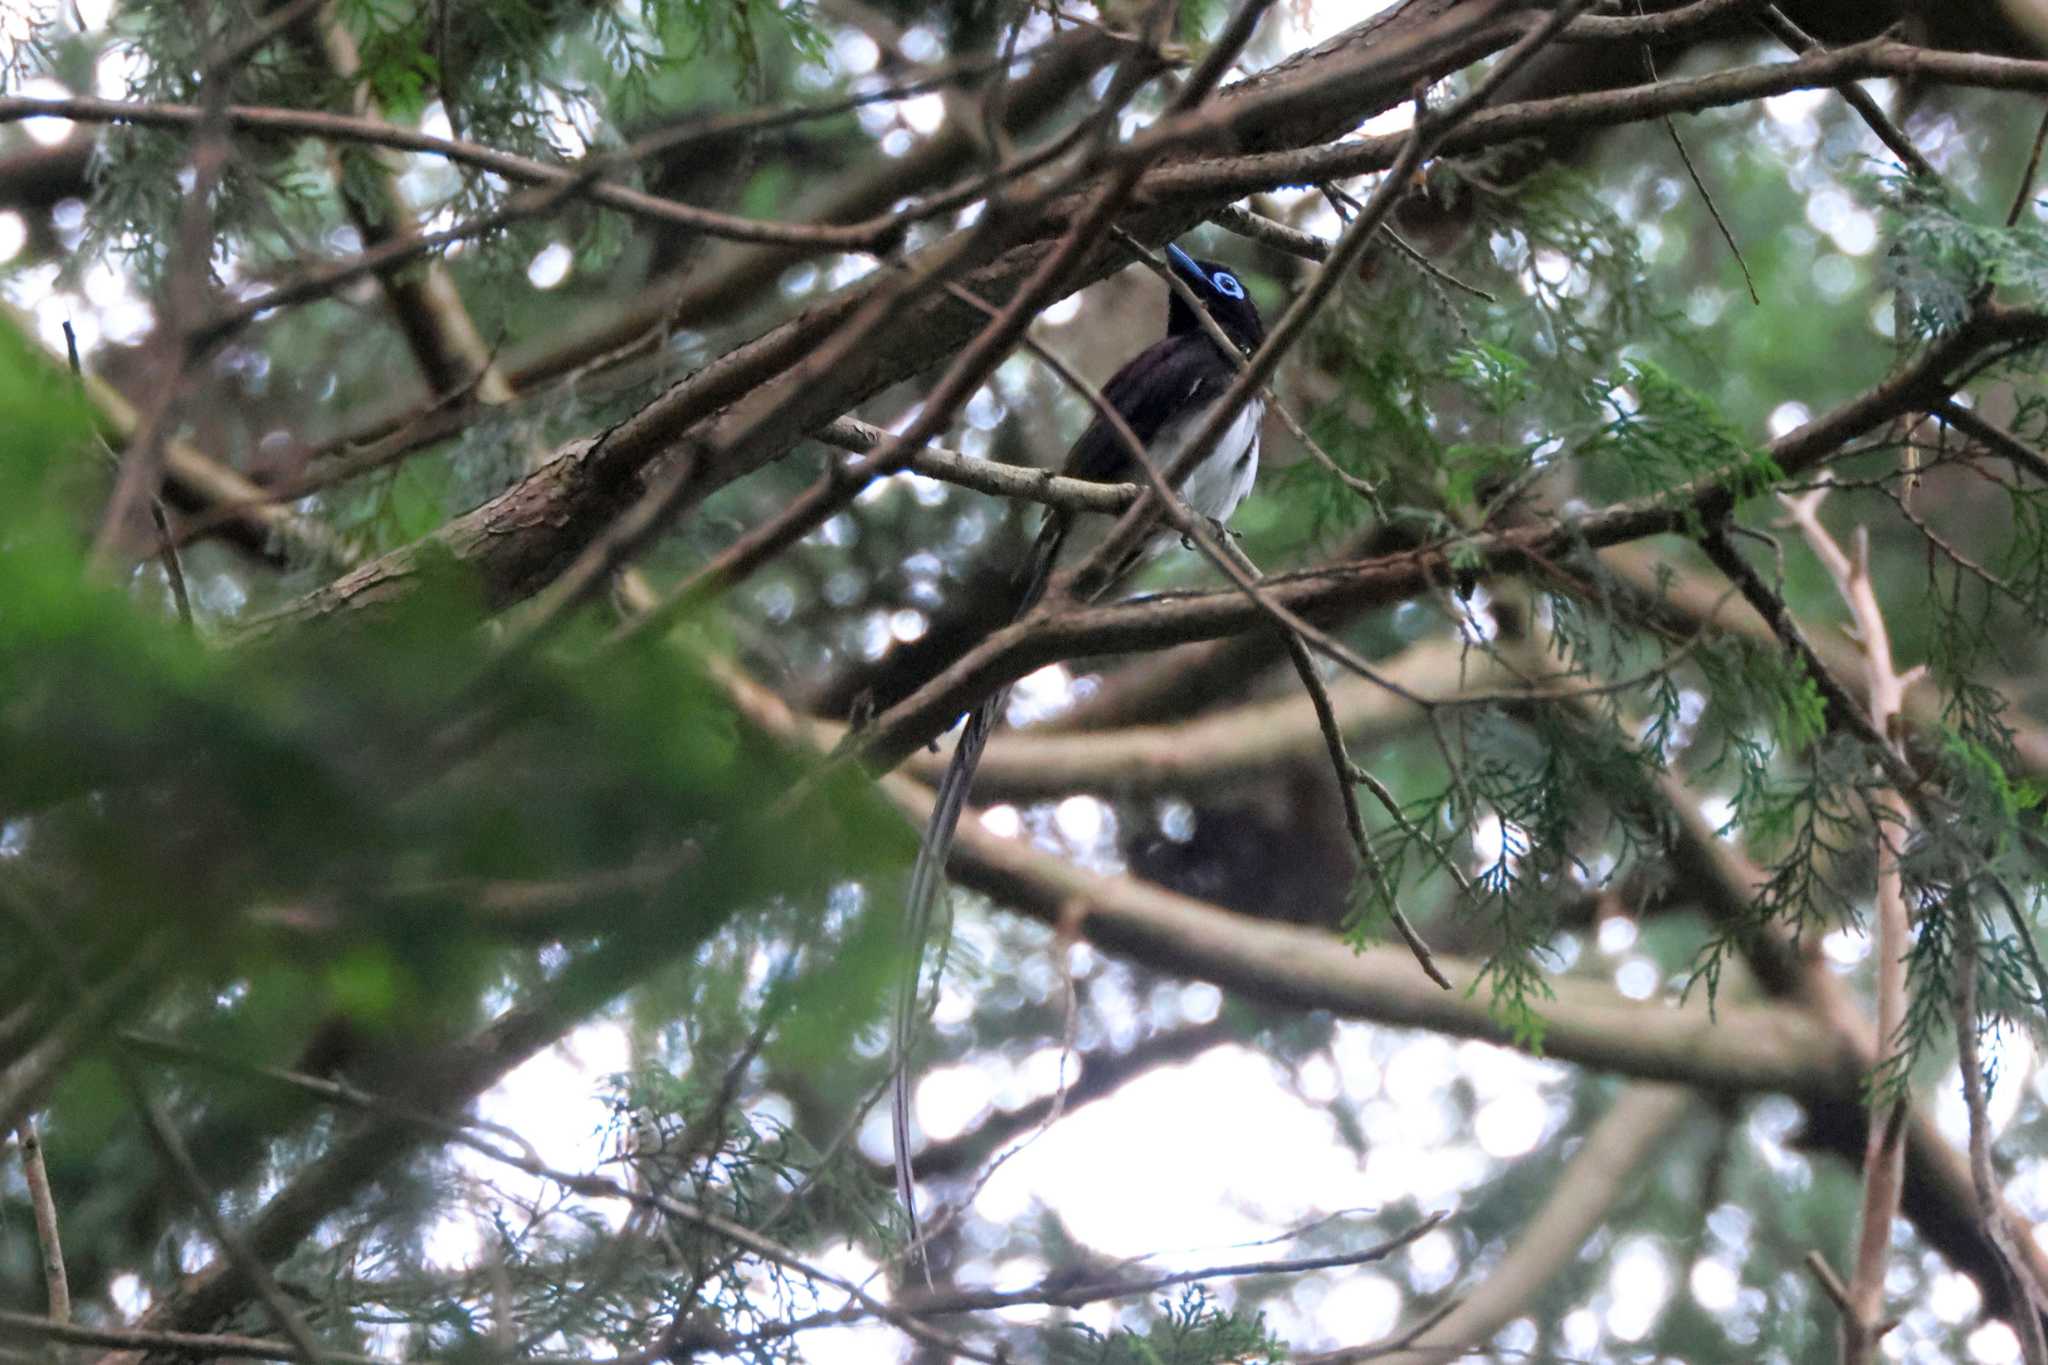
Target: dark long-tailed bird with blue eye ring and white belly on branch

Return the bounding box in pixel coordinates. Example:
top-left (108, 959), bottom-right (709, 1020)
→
top-left (889, 244), bottom-right (1266, 1279)
